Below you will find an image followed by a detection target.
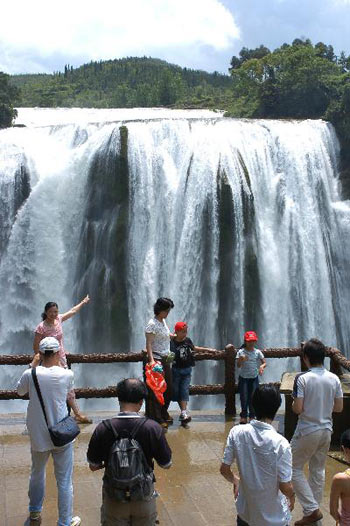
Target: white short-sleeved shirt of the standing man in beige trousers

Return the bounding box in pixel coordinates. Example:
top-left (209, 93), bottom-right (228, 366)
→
top-left (293, 366), bottom-right (343, 438)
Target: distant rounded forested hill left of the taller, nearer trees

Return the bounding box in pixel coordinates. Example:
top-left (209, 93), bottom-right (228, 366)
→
top-left (11, 57), bottom-right (232, 108)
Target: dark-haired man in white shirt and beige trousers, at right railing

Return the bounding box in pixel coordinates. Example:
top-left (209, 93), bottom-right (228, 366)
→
top-left (291, 338), bottom-right (343, 526)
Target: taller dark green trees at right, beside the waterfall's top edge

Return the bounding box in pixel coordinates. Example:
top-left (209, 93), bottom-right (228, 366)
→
top-left (226, 39), bottom-right (350, 194)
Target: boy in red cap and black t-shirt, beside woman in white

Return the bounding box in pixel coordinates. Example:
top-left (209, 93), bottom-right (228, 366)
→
top-left (170, 321), bottom-right (206, 424)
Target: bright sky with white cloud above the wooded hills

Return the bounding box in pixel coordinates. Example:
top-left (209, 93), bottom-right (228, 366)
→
top-left (0, 0), bottom-right (350, 73)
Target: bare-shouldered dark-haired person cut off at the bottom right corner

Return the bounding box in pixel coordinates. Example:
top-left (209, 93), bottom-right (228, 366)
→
top-left (329, 429), bottom-right (350, 526)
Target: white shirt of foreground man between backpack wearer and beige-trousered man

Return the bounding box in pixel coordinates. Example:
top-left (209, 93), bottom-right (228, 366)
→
top-left (222, 420), bottom-right (292, 526)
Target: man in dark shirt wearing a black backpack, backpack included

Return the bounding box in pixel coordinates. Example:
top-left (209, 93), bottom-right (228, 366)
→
top-left (87, 378), bottom-right (171, 526)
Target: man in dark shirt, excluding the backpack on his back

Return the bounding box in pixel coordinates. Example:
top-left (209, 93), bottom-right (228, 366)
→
top-left (87, 378), bottom-right (172, 526)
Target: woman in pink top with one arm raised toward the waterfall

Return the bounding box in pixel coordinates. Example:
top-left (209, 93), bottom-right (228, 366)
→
top-left (33, 295), bottom-right (92, 424)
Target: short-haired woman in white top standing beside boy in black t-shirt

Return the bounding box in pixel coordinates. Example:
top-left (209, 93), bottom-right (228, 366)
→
top-left (145, 298), bottom-right (174, 428)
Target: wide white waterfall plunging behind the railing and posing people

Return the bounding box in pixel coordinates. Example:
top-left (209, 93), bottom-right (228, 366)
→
top-left (0, 109), bottom-right (350, 412)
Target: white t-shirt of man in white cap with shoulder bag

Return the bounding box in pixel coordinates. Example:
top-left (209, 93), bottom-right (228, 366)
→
top-left (17, 365), bottom-right (73, 451)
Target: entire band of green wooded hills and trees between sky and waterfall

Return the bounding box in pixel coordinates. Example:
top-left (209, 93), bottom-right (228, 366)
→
top-left (0, 38), bottom-right (350, 186)
